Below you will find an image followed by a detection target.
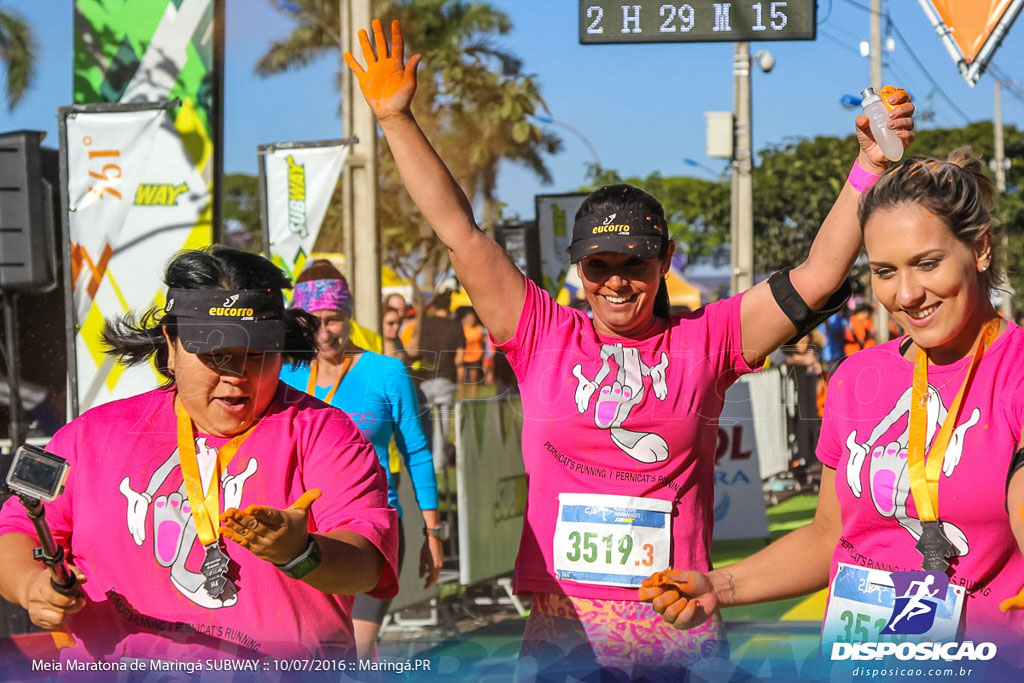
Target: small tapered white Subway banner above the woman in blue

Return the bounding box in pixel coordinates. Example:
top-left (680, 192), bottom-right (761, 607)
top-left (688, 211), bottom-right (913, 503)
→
top-left (259, 140), bottom-right (351, 286)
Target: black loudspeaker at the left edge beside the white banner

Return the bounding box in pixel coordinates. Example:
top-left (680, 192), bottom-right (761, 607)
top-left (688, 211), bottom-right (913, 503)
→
top-left (0, 130), bottom-right (57, 292)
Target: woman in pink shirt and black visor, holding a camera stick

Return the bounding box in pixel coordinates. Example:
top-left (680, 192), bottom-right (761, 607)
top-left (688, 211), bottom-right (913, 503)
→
top-left (0, 247), bottom-right (397, 671)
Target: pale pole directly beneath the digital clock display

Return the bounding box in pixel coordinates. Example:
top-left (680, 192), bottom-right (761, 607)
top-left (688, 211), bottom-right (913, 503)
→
top-left (732, 43), bottom-right (754, 294)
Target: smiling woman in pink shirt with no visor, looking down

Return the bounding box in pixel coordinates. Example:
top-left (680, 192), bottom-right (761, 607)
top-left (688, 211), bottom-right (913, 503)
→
top-left (640, 147), bottom-right (1024, 666)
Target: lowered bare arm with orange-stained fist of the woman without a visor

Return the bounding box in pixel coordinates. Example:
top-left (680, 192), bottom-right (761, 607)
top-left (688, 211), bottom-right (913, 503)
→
top-left (639, 467), bottom-right (842, 629)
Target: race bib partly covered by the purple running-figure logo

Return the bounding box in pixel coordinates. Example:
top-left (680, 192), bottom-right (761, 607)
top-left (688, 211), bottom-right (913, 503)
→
top-left (821, 562), bottom-right (966, 643)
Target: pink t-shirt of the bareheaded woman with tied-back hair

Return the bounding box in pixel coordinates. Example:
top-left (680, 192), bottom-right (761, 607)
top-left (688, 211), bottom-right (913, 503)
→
top-left (817, 324), bottom-right (1024, 643)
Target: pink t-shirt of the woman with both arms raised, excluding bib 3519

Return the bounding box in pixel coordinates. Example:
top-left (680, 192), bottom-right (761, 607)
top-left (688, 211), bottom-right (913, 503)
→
top-left (501, 281), bottom-right (751, 600)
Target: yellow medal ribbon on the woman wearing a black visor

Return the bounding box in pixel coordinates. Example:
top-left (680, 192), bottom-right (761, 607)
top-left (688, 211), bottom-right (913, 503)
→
top-left (174, 399), bottom-right (259, 547)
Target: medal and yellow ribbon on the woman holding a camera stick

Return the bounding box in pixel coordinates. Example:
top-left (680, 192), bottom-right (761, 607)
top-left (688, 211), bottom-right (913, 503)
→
top-left (175, 401), bottom-right (259, 600)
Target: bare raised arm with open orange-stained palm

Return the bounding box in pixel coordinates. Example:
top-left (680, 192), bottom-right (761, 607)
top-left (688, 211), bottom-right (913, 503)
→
top-left (345, 19), bottom-right (526, 342)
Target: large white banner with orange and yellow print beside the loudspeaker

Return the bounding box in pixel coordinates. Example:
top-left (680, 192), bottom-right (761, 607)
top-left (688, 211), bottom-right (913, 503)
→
top-left (67, 109), bottom-right (211, 413)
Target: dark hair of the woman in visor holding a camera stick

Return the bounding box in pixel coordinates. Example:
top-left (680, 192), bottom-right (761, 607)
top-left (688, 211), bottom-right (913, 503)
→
top-left (102, 245), bottom-right (319, 386)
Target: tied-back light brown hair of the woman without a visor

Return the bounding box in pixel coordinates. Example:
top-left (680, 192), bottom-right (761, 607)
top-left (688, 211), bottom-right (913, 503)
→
top-left (858, 146), bottom-right (999, 291)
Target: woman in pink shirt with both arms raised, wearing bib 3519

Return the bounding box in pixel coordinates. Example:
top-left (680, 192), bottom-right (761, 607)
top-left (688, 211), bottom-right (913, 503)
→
top-left (345, 20), bottom-right (913, 677)
